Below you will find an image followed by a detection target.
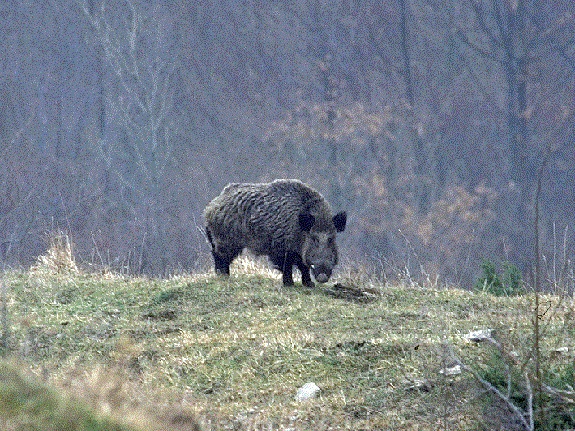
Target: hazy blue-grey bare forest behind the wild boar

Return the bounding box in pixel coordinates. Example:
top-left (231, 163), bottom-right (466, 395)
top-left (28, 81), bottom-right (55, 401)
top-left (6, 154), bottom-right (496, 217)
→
top-left (0, 0), bottom-right (575, 287)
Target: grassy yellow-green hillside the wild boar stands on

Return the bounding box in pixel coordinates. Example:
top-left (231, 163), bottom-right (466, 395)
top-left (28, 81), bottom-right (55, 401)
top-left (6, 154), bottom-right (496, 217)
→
top-left (0, 266), bottom-right (575, 430)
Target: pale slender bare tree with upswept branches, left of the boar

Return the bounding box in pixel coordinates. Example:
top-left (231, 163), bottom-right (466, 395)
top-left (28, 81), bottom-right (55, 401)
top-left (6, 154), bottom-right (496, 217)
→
top-left (78, 0), bottom-right (176, 271)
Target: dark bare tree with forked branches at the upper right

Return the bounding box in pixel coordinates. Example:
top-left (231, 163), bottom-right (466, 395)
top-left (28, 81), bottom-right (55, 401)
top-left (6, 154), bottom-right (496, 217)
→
top-left (457, 0), bottom-right (574, 186)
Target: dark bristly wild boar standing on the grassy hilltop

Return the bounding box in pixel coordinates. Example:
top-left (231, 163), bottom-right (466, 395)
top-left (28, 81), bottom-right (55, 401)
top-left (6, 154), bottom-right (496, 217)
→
top-left (204, 180), bottom-right (347, 286)
